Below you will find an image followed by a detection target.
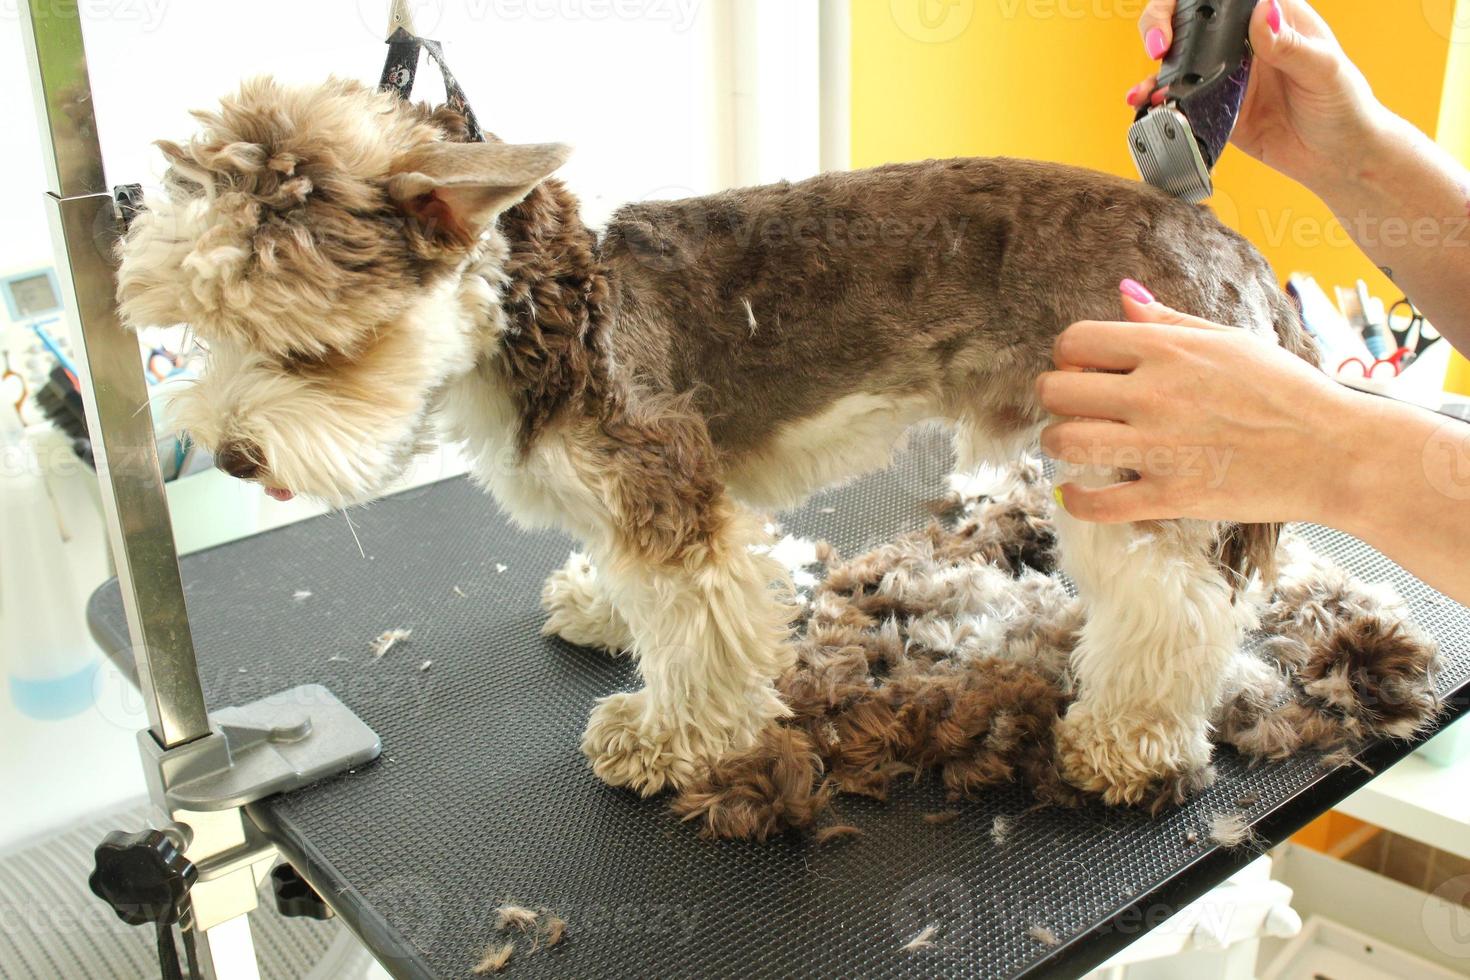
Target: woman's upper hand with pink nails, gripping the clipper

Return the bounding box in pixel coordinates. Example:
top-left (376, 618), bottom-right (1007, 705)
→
top-left (1127, 0), bottom-right (1379, 192)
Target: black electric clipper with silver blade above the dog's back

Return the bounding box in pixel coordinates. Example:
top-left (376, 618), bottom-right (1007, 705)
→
top-left (1127, 0), bottom-right (1257, 203)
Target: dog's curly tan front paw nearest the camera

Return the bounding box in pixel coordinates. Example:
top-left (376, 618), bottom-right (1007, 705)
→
top-left (582, 691), bottom-right (711, 796)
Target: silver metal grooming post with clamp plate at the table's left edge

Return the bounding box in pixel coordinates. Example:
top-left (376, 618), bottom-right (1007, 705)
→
top-left (21, 0), bottom-right (382, 980)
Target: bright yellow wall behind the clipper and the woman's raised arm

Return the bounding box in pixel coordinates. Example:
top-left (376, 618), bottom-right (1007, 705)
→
top-left (853, 0), bottom-right (1452, 303)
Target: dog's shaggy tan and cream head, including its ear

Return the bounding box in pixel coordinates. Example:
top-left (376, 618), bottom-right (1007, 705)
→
top-left (118, 79), bottom-right (567, 504)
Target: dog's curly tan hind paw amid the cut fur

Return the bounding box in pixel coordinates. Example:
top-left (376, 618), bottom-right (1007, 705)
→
top-left (1055, 702), bottom-right (1214, 811)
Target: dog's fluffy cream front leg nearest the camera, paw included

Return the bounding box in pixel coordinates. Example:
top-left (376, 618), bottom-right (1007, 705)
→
top-left (582, 497), bottom-right (792, 795)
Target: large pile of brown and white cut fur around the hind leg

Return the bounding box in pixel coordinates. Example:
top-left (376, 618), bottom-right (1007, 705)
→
top-left (673, 466), bottom-right (1439, 843)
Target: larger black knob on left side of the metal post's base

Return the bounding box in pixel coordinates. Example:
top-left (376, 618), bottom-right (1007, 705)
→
top-left (87, 830), bottom-right (198, 926)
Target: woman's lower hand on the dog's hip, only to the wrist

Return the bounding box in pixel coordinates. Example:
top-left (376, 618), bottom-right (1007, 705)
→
top-left (1036, 281), bottom-right (1372, 523)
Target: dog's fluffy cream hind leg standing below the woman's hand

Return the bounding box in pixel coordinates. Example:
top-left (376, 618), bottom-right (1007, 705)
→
top-left (1057, 467), bottom-right (1250, 804)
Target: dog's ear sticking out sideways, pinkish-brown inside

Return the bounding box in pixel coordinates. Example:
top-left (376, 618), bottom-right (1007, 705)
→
top-left (388, 143), bottom-right (572, 248)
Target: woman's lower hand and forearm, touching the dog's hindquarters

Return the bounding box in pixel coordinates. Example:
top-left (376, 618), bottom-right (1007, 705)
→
top-left (1036, 279), bottom-right (1470, 604)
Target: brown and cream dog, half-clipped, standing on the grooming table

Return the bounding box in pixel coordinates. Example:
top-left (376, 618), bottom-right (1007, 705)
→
top-left (118, 79), bottom-right (1311, 804)
